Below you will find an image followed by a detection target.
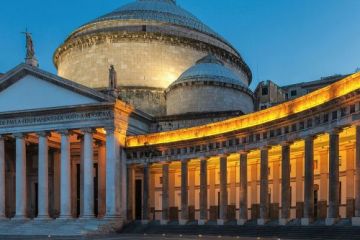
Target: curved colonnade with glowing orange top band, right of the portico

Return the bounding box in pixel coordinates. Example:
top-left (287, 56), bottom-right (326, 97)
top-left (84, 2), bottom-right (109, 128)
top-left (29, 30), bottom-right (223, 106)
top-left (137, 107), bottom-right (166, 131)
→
top-left (126, 74), bottom-right (360, 225)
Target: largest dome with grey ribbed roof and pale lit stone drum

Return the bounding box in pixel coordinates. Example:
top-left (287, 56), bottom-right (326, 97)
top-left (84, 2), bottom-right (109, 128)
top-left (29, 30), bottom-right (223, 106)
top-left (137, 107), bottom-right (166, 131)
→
top-left (54, 0), bottom-right (252, 115)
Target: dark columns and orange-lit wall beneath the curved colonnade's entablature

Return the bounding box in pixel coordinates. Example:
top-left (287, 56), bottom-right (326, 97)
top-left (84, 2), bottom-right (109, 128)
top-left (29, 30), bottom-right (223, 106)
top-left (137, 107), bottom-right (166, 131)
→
top-left (129, 127), bottom-right (360, 225)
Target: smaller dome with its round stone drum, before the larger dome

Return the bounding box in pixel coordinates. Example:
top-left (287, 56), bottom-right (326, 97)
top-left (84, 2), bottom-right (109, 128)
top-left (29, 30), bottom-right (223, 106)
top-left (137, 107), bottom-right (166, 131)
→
top-left (166, 55), bottom-right (254, 115)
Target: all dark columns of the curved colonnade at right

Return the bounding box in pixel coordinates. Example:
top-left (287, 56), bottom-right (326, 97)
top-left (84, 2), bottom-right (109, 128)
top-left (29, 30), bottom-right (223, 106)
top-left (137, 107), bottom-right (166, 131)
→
top-left (139, 127), bottom-right (360, 225)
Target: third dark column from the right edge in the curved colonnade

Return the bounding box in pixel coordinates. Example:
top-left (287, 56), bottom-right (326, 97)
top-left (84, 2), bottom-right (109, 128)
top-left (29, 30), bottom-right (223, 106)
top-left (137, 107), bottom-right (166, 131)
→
top-left (301, 136), bottom-right (314, 226)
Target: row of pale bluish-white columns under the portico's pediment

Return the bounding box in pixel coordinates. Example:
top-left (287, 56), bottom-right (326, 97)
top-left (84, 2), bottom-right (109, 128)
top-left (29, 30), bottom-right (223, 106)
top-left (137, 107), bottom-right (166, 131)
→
top-left (0, 128), bottom-right (126, 220)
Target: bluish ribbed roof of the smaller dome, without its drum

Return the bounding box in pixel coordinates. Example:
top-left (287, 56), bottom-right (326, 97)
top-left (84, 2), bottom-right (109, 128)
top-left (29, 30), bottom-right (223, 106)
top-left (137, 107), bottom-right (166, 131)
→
top-left (169, 55), bottom-right (247, 89)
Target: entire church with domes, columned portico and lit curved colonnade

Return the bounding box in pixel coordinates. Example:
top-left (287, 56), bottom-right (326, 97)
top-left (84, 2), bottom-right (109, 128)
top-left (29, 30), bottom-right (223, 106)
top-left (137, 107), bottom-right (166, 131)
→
top-left (0, 0), bottom-right (360, 232)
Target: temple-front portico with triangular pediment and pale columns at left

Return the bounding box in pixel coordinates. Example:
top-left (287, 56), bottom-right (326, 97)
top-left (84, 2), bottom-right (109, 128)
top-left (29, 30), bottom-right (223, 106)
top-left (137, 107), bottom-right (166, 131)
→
top-left (0, 65), bottom-right (132, 221)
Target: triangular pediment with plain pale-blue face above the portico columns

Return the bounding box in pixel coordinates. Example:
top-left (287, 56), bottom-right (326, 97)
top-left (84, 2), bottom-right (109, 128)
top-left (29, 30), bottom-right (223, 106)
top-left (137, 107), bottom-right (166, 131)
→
top-left (0, 64), bottom-right (113, 112)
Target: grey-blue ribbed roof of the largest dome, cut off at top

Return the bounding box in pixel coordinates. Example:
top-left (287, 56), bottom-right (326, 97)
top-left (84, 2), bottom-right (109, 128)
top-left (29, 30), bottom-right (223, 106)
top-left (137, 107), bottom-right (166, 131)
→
top-left (90, 0), bottom-right (226, 42)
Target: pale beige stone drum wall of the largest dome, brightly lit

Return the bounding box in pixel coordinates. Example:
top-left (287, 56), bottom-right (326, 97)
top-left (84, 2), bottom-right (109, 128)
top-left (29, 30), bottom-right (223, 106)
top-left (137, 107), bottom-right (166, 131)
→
top-left (58, 40), bottom-right (207, 89)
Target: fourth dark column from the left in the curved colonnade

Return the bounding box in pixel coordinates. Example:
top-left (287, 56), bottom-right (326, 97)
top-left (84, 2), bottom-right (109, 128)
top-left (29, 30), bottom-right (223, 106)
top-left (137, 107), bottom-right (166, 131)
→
top-left (198, 158), bottom-right (208, 225)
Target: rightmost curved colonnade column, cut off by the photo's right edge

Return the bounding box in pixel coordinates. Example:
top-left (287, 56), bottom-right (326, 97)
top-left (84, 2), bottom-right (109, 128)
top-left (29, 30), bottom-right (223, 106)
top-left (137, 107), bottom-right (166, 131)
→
top-left (351, 125), bottom-right (360, 226)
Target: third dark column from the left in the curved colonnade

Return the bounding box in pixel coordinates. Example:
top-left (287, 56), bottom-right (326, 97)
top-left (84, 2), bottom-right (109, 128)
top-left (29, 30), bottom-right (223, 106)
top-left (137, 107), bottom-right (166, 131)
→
top-left (179, 159), bottom-right (189, 225)
